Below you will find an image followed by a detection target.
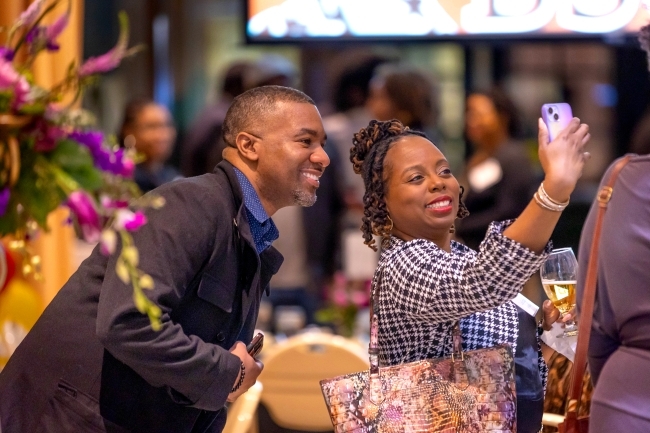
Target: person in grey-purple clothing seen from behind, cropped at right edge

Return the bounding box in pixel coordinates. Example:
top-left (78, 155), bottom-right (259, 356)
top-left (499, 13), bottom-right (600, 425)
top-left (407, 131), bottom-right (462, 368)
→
top-left (577, 155), bottom-right (650, 433)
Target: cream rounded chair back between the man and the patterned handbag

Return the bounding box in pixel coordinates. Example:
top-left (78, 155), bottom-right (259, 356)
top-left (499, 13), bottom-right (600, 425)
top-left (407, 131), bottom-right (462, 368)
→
top-left (258, 332), bottom-right (369, 431)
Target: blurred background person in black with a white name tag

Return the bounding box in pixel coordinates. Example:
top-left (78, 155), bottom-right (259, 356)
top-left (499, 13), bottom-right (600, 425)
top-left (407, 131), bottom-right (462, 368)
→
top-left (456, 89), bottom-right (537, 249)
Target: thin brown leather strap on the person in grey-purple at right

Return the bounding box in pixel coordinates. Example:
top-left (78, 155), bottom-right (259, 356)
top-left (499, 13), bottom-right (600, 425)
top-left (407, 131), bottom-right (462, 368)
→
top-left (567, 155), bottom-right (632, 417)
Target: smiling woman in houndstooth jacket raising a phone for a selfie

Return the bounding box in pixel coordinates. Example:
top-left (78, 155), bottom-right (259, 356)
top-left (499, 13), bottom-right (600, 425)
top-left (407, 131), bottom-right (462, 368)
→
top-left (350, 119), bottom-right (589, 433)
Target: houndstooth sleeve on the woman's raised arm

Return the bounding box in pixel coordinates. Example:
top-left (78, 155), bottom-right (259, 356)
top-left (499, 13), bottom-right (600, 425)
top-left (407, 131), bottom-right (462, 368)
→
top-left (386, 221), bottom-right (550, 322)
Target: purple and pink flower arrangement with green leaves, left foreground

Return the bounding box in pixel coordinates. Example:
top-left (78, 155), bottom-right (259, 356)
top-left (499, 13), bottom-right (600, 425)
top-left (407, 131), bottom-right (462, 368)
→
top-left (0, 0), bottom-right (164, 329)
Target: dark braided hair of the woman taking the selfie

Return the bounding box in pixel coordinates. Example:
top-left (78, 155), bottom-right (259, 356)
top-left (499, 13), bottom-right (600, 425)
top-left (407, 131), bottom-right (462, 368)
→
top-left (350, 119), bottom-right (466, 251)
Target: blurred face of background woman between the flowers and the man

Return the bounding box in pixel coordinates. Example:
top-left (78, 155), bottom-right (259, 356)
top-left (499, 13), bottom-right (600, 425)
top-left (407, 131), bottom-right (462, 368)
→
top-left (129, 104), bottom-right (176, 162)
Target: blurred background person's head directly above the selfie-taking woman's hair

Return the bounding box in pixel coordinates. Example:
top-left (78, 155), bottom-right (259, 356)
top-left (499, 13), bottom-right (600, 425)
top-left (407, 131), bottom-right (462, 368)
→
top-left (366, 64), bottom-right (444, 148)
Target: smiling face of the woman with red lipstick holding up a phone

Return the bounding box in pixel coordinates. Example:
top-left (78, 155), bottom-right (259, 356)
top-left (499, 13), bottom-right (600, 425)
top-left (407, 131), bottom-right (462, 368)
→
top-left (384, 135), bottom-right (460, 246)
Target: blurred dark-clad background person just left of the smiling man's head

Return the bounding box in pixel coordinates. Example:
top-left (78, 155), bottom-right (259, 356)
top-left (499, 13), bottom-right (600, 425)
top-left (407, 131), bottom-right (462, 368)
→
top-left (181, 61), bottom-right (251, 176)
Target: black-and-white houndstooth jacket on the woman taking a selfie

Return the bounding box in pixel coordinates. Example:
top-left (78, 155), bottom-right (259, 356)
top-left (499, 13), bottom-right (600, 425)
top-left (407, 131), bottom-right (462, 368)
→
top-left (373, 221), bottom-right (551, 385)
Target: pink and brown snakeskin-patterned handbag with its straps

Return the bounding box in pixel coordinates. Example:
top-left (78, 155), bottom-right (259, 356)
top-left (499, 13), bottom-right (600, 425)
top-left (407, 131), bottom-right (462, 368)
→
top-left (320, 273), bottom-right (517, 433)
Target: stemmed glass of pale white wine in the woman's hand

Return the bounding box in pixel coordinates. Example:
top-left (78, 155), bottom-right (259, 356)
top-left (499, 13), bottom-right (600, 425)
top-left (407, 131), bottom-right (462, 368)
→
top-left (540, 248), bottom-right (578, 338)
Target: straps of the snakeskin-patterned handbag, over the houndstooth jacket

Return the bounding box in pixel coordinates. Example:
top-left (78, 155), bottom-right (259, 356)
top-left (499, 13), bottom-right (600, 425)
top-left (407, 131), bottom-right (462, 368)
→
top-left (368, 267), bottom-right (464, 404)
